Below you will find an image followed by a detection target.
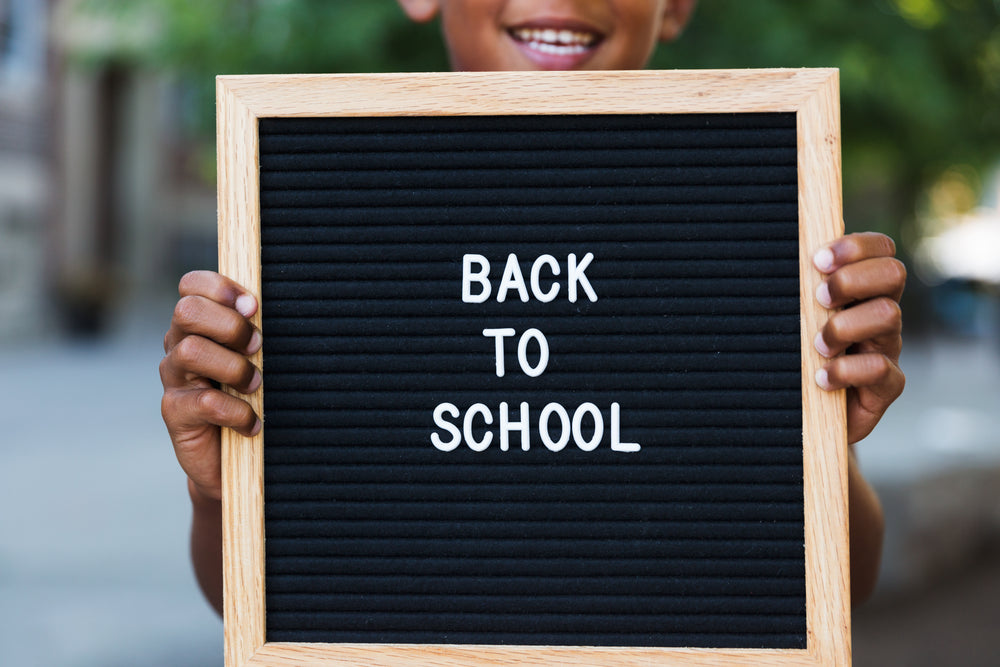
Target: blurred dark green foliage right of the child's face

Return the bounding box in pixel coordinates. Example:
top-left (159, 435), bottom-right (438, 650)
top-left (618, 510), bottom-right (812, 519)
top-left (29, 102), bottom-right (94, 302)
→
top-left (653, 0), bottom-right (1000, 238)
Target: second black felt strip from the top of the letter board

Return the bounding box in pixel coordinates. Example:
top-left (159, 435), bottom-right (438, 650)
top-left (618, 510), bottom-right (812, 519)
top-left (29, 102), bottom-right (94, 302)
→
top-left (259, 127), bottom-right (797, 155)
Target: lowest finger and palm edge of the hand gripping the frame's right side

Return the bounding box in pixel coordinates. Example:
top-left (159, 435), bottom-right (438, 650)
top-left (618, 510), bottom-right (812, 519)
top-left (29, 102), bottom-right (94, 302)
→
top-left (816, 354), bottom-right (906, 443)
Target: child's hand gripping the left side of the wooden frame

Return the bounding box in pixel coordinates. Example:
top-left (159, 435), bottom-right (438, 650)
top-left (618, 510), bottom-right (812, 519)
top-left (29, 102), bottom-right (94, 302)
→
top-left (160, 271), bottom-right (261, 500)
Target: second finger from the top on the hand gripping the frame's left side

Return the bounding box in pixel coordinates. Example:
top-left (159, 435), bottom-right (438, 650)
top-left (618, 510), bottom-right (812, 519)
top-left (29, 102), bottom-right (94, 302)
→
top-left (163, 295), bottom-right (262, 354)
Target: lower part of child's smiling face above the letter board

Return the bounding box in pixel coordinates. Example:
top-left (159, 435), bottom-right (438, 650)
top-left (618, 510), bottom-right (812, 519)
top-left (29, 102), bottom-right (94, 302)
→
top-left (399, 0), bottom-right (694, 71)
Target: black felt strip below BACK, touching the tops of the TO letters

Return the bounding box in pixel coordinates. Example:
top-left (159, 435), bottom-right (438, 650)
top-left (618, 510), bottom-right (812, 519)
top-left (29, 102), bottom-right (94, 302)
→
top-left (264, 316), bottom-right (799, 340)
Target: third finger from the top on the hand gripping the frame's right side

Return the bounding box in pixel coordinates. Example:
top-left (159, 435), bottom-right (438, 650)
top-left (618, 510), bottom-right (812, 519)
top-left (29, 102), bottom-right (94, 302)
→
top-left (814, 297), bottom-right (903, 358)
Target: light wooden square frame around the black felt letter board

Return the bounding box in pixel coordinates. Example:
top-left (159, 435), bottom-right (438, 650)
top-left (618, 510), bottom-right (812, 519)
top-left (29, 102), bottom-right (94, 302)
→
top-left (217, 69), bottom-right (851, 667)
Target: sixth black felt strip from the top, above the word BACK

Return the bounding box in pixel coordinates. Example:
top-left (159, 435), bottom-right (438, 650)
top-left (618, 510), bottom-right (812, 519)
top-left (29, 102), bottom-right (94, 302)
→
top-left (261, 202), bottom-right (798, 226)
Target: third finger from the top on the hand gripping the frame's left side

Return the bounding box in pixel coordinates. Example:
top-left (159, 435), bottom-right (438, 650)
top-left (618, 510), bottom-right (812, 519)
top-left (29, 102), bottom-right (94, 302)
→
top-left (160, 336), bottom-right (262, 394)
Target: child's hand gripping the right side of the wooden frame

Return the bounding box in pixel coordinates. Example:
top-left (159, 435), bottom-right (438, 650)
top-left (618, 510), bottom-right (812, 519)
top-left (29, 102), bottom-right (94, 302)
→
top-left (813, 233), bottom-right (906, 443)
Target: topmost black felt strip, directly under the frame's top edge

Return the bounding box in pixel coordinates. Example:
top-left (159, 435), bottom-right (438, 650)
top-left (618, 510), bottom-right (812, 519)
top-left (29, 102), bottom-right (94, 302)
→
top-left (259, 112), bottom-right (796, 135)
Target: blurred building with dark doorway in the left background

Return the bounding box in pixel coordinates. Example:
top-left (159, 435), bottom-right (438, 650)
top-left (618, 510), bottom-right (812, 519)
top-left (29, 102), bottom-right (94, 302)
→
top-left (0, 0), bottom-right (215, 339)
